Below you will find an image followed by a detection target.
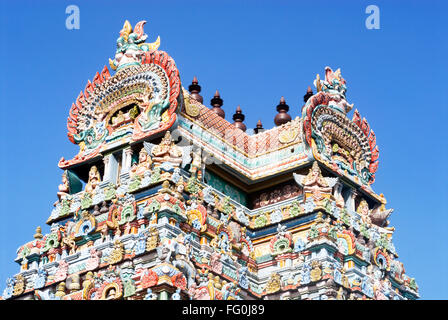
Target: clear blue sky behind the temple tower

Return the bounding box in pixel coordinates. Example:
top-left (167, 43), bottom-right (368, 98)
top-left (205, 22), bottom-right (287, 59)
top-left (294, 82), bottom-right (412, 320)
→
top-left (0, 0), bottom-right (448, 299)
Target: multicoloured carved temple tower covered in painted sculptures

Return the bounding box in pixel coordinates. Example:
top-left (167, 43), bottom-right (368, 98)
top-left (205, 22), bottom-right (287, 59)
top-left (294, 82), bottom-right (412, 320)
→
top-left (2, 21), bottom-right (419, 300)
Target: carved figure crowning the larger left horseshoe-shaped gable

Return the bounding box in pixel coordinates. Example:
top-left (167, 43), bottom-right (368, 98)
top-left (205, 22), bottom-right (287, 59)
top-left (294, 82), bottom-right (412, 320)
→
top-left (109, 20), bottom-right (160, 71)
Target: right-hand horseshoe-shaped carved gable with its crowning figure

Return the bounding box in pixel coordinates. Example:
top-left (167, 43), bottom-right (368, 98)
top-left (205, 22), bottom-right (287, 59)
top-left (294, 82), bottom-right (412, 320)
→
top-left (302, 67), bottom-right (379, 187)
